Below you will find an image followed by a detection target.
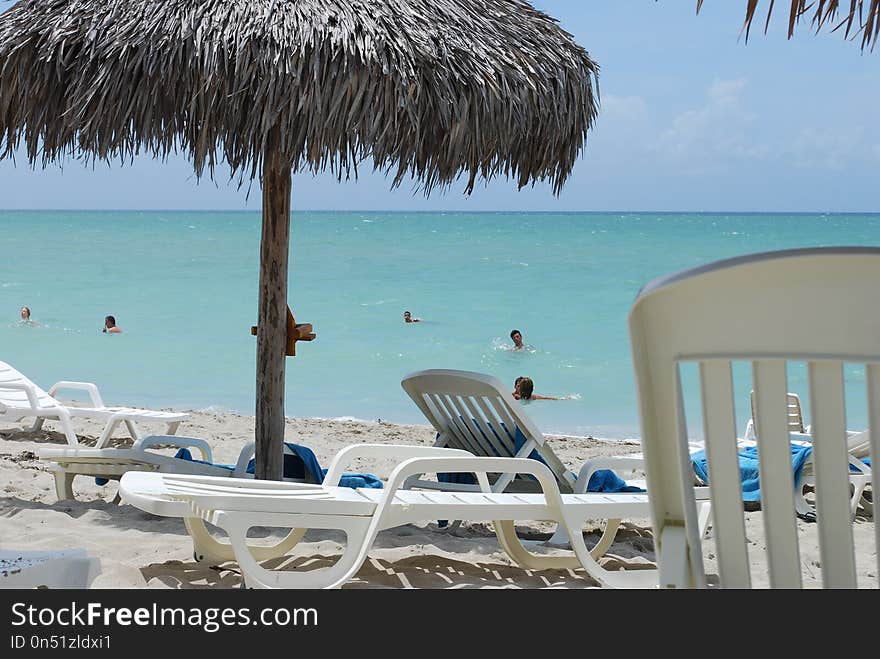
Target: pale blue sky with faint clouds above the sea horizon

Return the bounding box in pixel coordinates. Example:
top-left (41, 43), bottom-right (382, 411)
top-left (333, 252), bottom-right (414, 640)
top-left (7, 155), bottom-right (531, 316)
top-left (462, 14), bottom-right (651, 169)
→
top-left (0, 0), bottom-right (880, 212)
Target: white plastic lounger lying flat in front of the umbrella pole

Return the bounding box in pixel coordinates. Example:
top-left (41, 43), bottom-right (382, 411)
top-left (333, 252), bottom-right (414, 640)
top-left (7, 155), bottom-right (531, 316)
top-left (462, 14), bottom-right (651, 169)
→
top-left (120, 444), bottom-right (657, 588)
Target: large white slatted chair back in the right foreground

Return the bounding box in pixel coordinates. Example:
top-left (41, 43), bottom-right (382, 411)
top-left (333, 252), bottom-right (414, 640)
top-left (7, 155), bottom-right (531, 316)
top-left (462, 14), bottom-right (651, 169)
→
top-left (629, 248), bottom-right (880, 588)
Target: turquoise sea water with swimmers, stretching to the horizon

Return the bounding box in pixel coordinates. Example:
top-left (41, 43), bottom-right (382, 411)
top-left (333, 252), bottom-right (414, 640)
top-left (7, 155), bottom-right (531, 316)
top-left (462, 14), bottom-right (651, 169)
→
top-left (0, 211), bottom-right (880, 438)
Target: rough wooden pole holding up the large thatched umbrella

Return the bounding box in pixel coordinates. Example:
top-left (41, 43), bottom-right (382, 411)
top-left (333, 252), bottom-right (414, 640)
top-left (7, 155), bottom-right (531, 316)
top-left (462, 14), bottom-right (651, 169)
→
top-left (255, 128), bottom-right (291, 480)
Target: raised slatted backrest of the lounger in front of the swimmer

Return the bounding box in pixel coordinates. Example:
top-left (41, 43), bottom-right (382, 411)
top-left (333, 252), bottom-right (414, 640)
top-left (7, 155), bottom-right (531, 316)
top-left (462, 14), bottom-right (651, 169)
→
top-left (401, 369), bottom-right (575, 491)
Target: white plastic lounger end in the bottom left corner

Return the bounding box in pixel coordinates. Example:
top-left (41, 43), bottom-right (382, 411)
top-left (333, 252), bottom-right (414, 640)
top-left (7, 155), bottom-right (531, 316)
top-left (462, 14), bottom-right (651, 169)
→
top-left (0, 549), bottom-right (101, 588)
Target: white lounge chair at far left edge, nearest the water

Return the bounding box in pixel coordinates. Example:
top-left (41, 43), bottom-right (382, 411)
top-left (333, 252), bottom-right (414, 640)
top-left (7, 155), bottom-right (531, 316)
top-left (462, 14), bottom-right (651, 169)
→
top-left (0, 362), bottom-right (189, 448)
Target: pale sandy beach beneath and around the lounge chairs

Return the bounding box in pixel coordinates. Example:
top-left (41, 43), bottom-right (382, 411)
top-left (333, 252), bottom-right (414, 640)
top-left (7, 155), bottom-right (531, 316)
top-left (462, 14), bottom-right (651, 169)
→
top-left (0, 411), bottom-right (878, 589)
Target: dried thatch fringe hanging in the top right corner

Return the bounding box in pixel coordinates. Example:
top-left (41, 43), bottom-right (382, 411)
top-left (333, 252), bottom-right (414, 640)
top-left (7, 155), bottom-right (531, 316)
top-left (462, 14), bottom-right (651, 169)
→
top-left (697, 0), bottom-right (880, 50)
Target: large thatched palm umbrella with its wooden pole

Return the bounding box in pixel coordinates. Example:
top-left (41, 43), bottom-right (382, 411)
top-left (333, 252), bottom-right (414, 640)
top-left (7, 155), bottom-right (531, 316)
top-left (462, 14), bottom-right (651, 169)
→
top-left (0, 0), bottom-right (597, 478)
